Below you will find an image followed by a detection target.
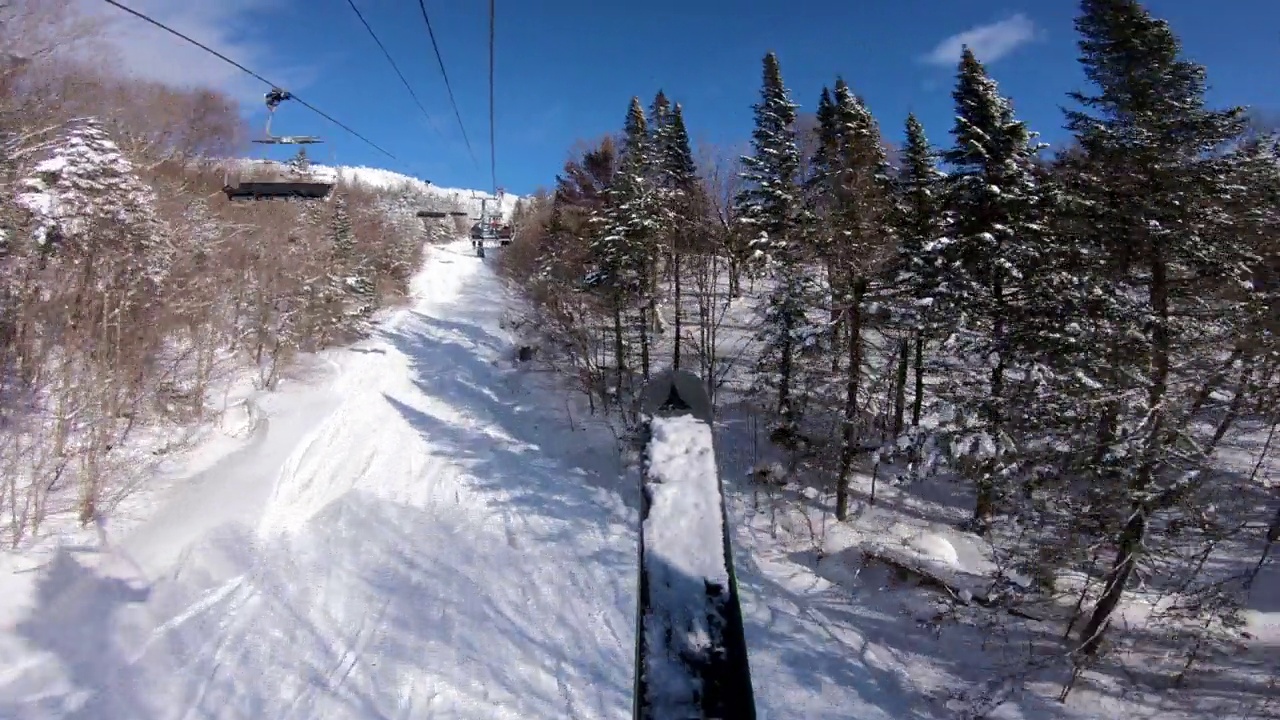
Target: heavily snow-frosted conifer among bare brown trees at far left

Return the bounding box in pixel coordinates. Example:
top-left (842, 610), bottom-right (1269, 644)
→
top-left (17, 118), bottom-right (174, 523)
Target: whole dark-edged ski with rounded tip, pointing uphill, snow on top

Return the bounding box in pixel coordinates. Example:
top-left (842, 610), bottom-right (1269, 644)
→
top-left (634, 370), bottom-right (755, 720)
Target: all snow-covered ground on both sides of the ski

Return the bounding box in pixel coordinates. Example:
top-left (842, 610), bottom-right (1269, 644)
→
top-left (0, 233), bottom-right (1280, 720)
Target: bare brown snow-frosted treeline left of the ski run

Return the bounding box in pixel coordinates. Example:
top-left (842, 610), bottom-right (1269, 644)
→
top-left (0, 0), bottom-right (452, 538)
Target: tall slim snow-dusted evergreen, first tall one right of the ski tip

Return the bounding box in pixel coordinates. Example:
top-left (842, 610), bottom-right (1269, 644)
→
top-left (735, 53), bottom-right (814, 437)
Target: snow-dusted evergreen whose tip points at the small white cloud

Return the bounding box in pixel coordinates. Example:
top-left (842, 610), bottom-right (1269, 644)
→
top-left (927, 47), bottom-right (1043, 530)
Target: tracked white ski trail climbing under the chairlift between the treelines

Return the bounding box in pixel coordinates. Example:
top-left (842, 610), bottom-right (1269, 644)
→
top-left (0, 241), bottom-right (919, 720)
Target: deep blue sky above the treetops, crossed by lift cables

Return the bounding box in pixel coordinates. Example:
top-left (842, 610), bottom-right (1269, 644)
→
top-left (102, 0), bottom-right (1280, 193)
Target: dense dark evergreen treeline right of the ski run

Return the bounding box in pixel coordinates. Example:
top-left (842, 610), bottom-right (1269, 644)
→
top-left (503, 0), bottom-right (1280, 680)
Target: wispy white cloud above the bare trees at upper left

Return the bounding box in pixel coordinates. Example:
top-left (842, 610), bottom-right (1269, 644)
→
top-left (74, 0), bottom-right (310, 101)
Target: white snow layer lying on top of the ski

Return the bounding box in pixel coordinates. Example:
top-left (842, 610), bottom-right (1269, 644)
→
top-left (644, 415), bottom-right (730, 717)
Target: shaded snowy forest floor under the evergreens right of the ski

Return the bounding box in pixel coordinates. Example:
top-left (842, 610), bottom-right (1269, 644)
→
top-left (650, 270), bottom-right (1280, 720)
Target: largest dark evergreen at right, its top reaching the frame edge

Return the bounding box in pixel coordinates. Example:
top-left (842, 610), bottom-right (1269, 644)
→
top-left (1066, 0), bottom-right (1256, 655)
